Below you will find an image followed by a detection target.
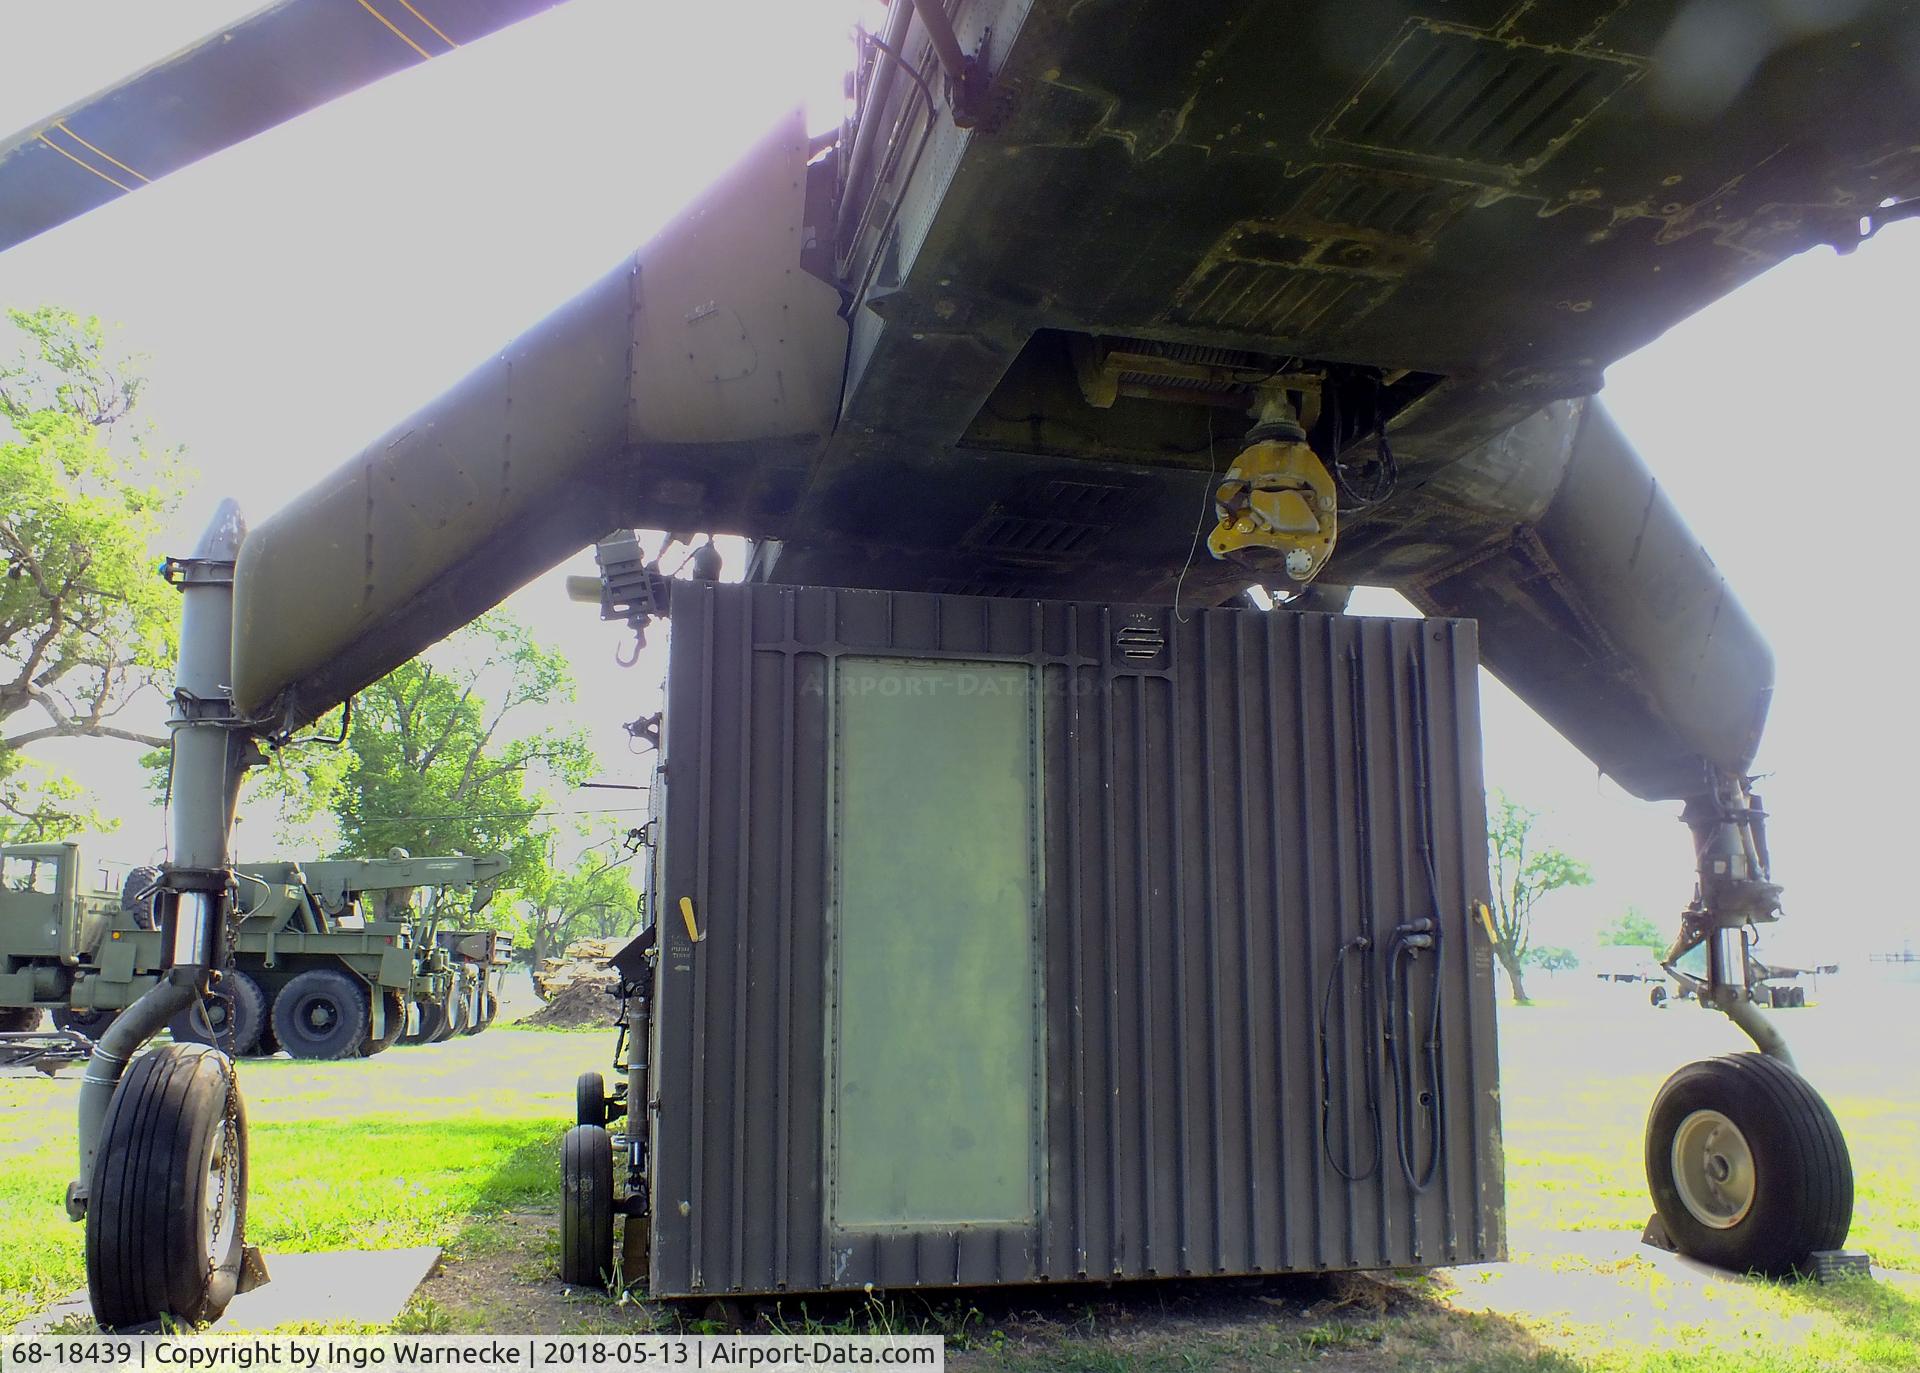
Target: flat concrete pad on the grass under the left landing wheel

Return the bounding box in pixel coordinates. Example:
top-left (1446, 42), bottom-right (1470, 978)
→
top-left (13, 1244), bottom-right (440, 1335)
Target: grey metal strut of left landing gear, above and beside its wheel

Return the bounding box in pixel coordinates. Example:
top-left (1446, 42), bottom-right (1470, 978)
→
top-left (67, 501), bottom-right (246, 1219)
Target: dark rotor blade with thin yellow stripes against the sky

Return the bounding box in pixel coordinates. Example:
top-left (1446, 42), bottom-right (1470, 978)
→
top-left (0, 0), bottom-right (561, 252)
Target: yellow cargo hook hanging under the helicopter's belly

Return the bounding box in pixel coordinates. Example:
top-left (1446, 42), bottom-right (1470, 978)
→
top-left (1206, 390), bottom-right (1340, 590)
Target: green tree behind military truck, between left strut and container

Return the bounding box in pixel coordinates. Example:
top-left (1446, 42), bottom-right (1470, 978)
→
top-left (250, 611), bottom-right (597, 893)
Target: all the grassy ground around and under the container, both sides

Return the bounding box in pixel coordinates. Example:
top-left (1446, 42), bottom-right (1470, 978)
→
top-left (0, 977), bottom-right (1920, 1373)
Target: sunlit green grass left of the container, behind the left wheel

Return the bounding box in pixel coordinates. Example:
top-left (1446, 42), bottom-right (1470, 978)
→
top-left (0, 1025), bottom-right (612, 1329)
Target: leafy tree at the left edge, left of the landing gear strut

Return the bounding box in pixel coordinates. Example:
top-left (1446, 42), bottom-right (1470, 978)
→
top-left (0, 309), bottom-right (180, 837)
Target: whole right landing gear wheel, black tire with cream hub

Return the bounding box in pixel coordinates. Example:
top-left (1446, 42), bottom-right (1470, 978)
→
top-left (1647, 1054), bottom-right (1853, 1277)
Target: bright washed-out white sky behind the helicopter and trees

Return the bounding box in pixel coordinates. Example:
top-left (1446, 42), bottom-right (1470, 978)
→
top-left (0, 0), bottom-right (1920, 962)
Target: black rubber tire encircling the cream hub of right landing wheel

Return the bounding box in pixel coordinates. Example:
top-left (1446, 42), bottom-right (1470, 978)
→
top-left (1647, 1054), bottom-right (1853, 1277)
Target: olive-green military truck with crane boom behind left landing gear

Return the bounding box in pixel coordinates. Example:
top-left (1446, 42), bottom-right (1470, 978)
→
top-left (0, 843), bottom-right (511, 1058)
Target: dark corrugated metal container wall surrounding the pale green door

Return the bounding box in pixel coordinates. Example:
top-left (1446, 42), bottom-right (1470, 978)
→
top-left (651, 584), bottom-right (1503, 1296)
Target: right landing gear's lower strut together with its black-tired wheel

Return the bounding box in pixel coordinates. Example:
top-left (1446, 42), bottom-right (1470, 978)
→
top-left (1645, 774), bottom-right (1853, 1275)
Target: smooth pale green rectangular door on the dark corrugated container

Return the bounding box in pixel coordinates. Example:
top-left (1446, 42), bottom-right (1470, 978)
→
top-left (828, 657), bottom-right (1044, 1231)
